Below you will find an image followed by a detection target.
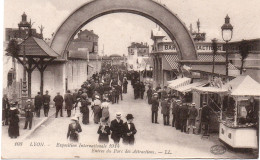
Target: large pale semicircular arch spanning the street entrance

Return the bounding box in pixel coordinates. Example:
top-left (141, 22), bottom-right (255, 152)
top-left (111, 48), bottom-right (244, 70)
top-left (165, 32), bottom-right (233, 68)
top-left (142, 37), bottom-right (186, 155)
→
top-left (51, 0), bottom-right (197, 60)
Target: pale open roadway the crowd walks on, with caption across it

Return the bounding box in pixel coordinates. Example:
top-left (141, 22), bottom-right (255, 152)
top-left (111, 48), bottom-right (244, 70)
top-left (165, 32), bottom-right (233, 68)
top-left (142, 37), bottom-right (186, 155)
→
top-left (0, 84), bottom-right (253, 158)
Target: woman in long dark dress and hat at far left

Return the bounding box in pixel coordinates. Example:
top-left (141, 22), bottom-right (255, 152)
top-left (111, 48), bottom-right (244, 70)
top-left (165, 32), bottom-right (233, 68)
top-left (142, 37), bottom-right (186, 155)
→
top-left (8, 102), bottom-right (20, 138)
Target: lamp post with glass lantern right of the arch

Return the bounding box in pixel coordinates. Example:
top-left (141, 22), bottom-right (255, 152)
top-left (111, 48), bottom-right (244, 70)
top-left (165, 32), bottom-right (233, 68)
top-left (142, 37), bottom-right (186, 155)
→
top-left (221, 15), bottom-right (233, 76)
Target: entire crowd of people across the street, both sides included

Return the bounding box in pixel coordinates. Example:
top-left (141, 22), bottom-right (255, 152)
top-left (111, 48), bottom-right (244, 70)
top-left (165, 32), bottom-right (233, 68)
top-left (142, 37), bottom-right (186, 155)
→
top-left (2, 66), bottom-right (213, 144)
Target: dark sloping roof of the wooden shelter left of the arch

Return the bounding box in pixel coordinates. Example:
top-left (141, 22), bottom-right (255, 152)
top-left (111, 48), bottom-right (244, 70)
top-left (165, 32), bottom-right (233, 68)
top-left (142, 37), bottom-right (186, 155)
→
top-left (18, 36), bottom-right (59, 57)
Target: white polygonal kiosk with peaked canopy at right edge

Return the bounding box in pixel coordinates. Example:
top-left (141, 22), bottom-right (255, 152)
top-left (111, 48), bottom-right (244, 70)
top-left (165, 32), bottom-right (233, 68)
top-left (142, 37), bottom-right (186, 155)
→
top-left (219, 76), bottom-right (260, 148)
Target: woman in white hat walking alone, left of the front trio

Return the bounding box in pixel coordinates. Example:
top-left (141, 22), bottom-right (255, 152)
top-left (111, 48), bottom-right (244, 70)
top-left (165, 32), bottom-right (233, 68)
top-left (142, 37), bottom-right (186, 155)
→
top-left (67, 117), bottom-right (82, 142)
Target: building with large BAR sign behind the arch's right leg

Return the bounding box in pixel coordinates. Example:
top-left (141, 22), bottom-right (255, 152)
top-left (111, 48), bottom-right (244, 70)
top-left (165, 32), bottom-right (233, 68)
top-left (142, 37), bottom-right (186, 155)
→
top-left (151, 25), bottom-right (239, 85)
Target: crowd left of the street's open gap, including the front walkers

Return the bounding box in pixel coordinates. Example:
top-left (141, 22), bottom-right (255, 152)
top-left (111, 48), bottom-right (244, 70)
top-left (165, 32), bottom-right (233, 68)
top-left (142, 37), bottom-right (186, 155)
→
top-left (2, 66), bottom-right (137, 145)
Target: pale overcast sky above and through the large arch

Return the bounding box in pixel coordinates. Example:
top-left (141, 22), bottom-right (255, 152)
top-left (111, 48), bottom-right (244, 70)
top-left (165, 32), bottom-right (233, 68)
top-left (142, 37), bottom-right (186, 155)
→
top-left (4, 0), bottom-right (260, 55)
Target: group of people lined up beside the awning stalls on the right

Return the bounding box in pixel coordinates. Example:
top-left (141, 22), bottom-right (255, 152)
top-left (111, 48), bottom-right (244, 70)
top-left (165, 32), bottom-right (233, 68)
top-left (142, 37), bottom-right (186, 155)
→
top-left (146, 85), bottom-right (210, 134)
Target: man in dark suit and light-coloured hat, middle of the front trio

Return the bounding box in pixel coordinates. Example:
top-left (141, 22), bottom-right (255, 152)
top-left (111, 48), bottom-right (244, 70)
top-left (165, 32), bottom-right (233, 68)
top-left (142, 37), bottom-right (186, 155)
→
top-left (110, 113), bottom-right (123, 143)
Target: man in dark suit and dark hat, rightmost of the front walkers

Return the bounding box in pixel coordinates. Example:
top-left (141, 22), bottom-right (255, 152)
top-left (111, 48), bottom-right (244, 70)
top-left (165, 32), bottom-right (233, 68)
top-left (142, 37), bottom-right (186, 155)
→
top-left (123, 114), bottom-right (137, 145)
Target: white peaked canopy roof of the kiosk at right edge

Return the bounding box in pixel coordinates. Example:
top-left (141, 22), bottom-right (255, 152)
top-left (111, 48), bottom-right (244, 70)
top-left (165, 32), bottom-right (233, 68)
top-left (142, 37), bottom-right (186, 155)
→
top-left (224, 75), bottom-right (260, 96)
